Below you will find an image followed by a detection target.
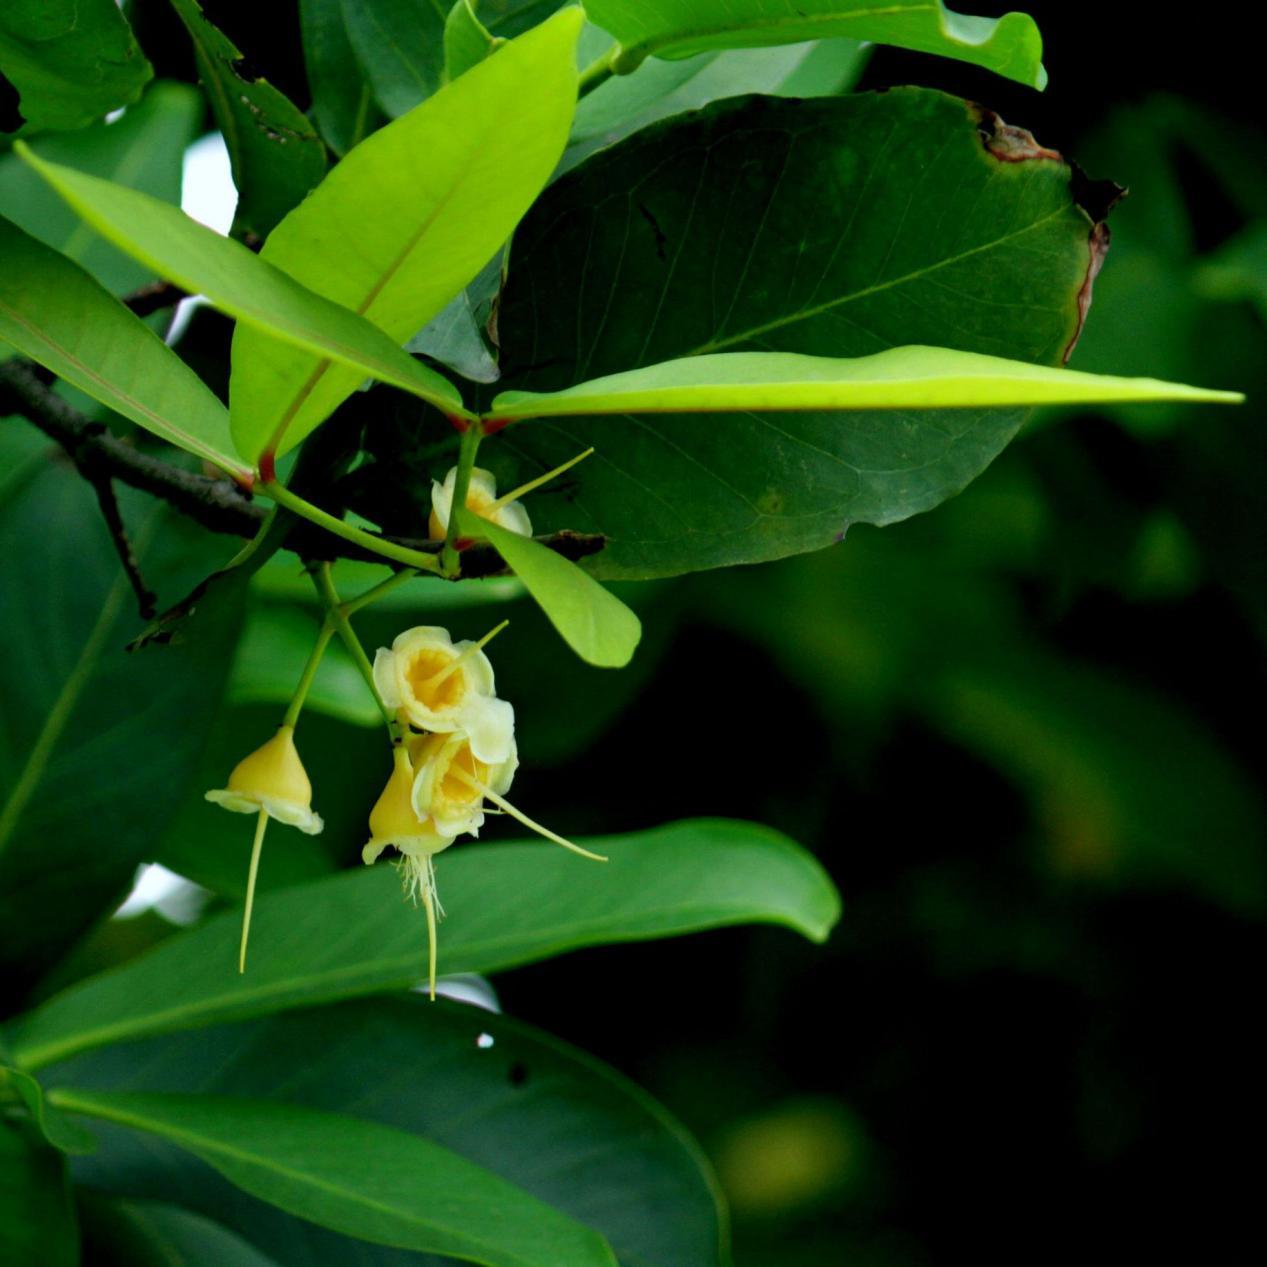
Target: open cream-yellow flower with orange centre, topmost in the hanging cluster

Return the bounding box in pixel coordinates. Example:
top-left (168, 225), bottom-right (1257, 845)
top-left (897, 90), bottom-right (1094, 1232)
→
top-left (374, 625), bottom-right (514, 764)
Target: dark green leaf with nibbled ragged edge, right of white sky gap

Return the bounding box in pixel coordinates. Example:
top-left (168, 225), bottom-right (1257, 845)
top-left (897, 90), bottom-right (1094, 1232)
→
top-left (171, 0), bottom-right (326, 237)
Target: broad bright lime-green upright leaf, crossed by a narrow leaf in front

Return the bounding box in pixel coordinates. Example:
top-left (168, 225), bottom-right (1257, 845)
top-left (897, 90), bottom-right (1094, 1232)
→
top-left (229, 9), bottom-right (580, 457)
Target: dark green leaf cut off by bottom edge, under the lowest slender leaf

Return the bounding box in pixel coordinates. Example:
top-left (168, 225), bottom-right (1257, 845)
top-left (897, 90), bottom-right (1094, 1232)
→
top-left (80, 1196), bottom-right (285, 1267)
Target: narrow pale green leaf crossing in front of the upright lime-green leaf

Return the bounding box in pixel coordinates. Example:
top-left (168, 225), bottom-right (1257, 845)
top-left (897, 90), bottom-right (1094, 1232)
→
top-left (19, 143), bottom-right (461, 435)
